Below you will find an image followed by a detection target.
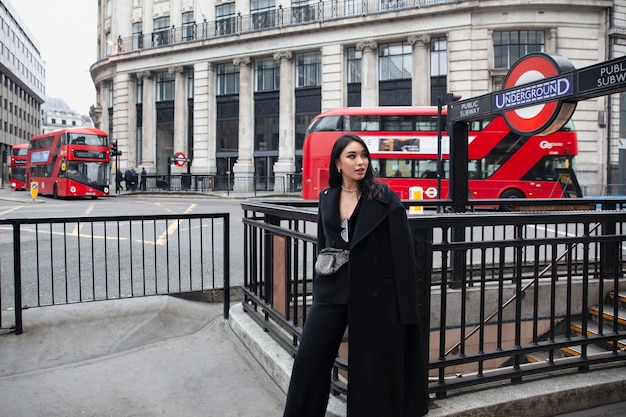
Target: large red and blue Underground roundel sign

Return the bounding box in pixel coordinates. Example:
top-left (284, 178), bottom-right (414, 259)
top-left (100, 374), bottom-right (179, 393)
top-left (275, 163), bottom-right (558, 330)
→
top-left (494, 53), bottom-right (576, 135)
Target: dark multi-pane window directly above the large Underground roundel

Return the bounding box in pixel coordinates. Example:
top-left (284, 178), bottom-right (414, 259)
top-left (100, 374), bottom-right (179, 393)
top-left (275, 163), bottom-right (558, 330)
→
top-left (493, 30), bottom-right (545, 69)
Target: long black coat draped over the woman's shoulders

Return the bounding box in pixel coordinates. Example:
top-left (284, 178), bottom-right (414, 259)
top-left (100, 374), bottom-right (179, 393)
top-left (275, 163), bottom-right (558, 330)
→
top-left (314, 187), bottom-right (429, 417)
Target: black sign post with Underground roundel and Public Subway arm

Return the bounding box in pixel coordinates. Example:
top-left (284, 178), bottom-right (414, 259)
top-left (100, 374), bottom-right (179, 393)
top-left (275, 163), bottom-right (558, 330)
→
top-left (447, 53), bottom-right (626, 287)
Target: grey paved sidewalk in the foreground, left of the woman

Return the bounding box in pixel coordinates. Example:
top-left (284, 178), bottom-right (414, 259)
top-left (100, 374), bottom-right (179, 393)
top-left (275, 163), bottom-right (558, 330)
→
top-left (0, 296), bottom-right (284, 417)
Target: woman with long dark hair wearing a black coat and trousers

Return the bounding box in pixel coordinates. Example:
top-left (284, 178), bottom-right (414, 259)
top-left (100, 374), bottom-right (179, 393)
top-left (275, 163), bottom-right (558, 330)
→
top-left (284, 135), bottom-right (429, 417)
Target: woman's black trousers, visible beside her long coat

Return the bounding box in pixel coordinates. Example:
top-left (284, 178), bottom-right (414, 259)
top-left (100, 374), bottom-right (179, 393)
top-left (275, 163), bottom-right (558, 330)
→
top-left (283, 301), bottom-right (348, 417)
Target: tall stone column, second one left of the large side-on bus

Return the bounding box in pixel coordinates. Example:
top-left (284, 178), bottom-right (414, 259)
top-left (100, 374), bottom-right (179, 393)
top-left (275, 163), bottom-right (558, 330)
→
top-left (233, 57), bottom-right (254, 192)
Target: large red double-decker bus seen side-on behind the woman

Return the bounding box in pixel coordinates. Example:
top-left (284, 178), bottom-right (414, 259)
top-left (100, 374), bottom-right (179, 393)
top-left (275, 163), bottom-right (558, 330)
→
top-left (302, 106), bottom-right (580, 200)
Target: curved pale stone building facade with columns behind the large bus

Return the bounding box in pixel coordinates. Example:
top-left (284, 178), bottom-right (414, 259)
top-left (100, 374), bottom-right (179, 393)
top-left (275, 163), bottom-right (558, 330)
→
top-left (91, 0), bottom-right (626, 189)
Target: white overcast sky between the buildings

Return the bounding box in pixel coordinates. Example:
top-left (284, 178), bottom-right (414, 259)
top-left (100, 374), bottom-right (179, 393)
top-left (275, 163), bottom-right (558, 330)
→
top-left (9, 0), bottom-right (98, 114)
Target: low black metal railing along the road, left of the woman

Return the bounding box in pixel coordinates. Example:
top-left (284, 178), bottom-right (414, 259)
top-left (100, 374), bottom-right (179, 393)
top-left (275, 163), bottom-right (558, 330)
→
top-left (0, 213), bottom-right (230, 334)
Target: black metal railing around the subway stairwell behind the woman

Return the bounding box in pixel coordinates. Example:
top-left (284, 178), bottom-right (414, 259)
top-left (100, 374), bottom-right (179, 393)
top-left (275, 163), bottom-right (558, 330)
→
top-left (242, 199), bottom-right (626, 397)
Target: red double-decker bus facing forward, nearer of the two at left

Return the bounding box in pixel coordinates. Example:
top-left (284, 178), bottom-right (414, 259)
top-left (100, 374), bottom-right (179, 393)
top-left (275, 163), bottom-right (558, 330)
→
top-left (26, 127), bottom-right (111, 198)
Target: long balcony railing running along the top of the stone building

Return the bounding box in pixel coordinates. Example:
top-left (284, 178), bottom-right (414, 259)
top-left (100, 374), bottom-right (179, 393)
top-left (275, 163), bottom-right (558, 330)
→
top-left (111, 0), bottom-right (458, 53)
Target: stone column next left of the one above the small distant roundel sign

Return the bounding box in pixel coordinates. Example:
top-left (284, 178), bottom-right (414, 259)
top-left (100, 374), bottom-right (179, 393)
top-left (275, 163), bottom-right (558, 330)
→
top-left (136, 71), bottom-right (156, 171)
